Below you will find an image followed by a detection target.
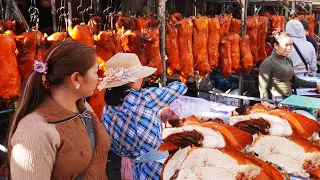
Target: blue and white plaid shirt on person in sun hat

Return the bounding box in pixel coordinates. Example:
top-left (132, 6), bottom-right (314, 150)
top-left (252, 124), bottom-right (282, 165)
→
top-left (102, 82), bottom-right (187, 180)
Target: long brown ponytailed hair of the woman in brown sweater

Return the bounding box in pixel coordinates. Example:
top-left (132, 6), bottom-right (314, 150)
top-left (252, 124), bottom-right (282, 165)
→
top-left (7, 41), bottom-right (97, 174)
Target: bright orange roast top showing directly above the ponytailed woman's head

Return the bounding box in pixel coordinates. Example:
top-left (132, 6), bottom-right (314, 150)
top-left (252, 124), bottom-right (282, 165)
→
top-left (68, 25), bottom-right (94, 47)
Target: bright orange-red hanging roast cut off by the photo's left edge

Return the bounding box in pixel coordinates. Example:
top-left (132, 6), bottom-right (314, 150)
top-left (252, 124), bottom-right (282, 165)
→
top-left (0, 34), bottom-right (21, 99)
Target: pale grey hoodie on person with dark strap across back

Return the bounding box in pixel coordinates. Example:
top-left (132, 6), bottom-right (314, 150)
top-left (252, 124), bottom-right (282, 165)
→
top-left (286, 20), bottom-right (318, 76)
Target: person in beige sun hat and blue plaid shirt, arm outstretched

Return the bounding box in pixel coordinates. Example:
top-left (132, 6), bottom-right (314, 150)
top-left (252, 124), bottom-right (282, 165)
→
top-left (98, 53), bottom-right (187, 180)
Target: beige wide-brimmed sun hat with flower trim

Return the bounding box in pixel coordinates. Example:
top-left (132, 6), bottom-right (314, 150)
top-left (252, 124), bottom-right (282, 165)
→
top-left (98, 53), bottom-right (157, 91)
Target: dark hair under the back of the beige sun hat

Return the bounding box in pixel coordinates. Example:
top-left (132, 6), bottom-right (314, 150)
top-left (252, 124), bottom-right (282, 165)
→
top-left (104, 85), bottom-right (131, 106)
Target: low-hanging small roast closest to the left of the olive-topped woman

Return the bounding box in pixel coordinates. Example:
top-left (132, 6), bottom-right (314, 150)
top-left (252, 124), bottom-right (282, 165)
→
top-left (240, 35), bottom-right (253, 74)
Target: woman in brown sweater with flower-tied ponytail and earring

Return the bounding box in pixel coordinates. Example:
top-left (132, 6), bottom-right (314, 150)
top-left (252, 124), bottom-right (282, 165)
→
top-left (8, 41), bottom-right (110, 180)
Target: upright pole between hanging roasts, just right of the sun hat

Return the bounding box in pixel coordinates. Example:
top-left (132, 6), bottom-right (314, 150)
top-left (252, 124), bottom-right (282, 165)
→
top-left (157, 0), bottom-right (167, 86)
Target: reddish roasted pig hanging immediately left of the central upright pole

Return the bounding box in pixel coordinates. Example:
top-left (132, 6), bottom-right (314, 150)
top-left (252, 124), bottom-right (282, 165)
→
top-left (146, 28), bottom-right (163, 82)
